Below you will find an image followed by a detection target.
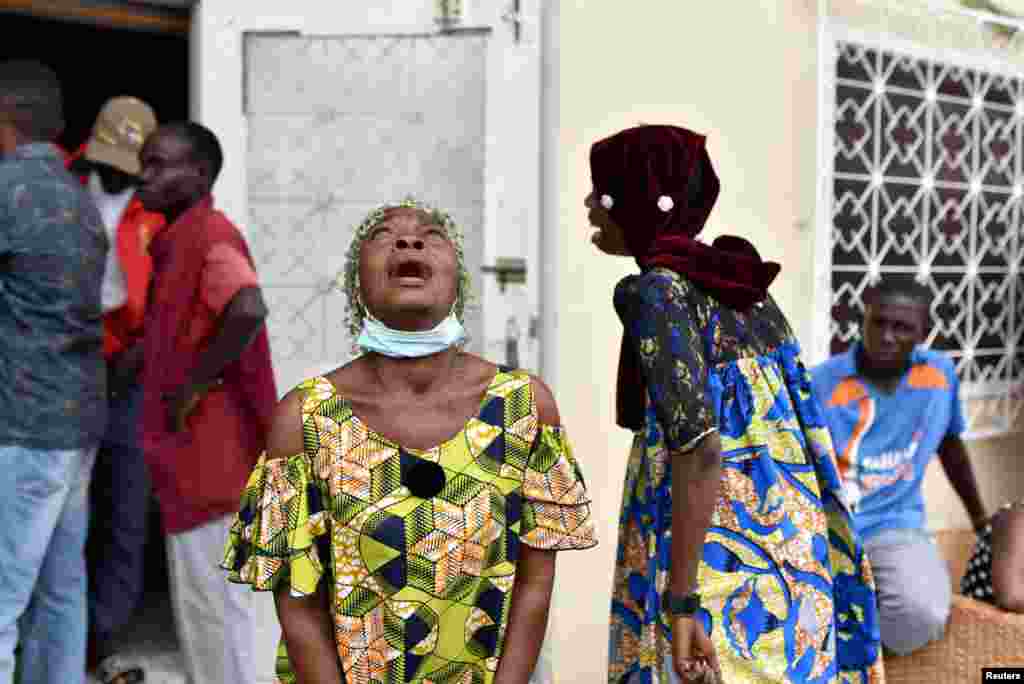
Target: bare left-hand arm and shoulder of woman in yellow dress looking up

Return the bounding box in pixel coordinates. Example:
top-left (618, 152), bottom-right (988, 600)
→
top-left (267, 391), bottom-right (342, 684)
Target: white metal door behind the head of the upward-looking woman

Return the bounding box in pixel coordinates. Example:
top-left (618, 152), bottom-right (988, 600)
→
top-left (243, 0), bottom-right (541, 391)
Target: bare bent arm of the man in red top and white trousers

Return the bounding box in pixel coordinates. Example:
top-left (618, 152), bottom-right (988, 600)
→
top-left (167, 288), bottom-right (268, 431)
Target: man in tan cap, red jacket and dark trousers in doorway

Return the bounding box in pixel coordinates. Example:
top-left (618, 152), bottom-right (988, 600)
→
top-left (71, 97), bottom-right (164, 684)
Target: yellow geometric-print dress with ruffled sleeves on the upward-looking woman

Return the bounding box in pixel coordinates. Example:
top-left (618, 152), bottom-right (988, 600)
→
top-left (222, 369), bottom-right (596, 684)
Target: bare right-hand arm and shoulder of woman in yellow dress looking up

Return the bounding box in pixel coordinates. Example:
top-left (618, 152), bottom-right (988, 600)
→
top-left (495, 378), bottom-right (562, 684)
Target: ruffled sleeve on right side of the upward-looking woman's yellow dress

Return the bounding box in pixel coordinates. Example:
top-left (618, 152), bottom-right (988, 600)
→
top-left (519, 425), bottom-right (597, 551)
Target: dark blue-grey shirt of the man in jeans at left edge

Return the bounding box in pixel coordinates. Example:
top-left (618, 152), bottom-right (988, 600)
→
top-left (0, 143), bottom-right (110, 451)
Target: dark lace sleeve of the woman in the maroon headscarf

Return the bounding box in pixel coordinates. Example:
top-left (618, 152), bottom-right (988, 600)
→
top-left (614, 269), bottom-right (717, 452)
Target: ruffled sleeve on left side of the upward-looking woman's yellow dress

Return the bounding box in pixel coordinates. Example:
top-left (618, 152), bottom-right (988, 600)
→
top-left (221, 454), bottom-right (330, 597)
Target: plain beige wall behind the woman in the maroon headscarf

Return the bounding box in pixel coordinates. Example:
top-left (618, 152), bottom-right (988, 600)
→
top-left (545, 0), bottom-right (1024, 683)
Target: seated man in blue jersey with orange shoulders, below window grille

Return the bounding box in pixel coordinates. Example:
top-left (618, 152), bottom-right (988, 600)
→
top-left (812, 273), bottom-right (987, 654)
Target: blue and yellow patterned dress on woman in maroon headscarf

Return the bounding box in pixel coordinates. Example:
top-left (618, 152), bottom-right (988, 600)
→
top-left (608, 269), bottom-right (884, 684)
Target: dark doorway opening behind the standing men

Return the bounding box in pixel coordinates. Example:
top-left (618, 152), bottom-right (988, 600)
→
top-left (0, 2), bottom-right (189, 681)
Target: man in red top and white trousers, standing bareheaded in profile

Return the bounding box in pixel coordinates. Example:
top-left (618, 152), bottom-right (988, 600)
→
top-left (139, 122), bottom-right (278, 684)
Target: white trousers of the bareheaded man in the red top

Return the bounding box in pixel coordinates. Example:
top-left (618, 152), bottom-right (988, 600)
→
top-left (167, 515), bottom-right (256, 684)
